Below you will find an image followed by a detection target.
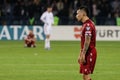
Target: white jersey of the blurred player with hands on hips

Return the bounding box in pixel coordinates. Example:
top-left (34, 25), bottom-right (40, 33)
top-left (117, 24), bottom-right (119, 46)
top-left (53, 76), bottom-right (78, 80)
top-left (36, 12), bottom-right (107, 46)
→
top-left (40, 11), bottom-right (54, 27)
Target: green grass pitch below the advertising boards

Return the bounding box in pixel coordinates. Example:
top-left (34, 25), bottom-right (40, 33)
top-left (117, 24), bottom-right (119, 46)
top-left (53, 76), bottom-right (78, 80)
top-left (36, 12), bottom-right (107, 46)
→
top-left (0, 41), bottom-right (120, 80)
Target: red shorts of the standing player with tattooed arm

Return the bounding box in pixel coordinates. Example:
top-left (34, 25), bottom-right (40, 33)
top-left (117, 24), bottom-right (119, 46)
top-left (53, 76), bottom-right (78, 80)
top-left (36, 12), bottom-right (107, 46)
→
top-left (80, 49), bottom-right (97, 75)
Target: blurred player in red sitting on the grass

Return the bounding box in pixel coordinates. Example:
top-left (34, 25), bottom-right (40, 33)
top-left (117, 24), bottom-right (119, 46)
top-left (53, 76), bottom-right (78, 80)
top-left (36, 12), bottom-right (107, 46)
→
top-left (24, 30), bottom-right (36, 47)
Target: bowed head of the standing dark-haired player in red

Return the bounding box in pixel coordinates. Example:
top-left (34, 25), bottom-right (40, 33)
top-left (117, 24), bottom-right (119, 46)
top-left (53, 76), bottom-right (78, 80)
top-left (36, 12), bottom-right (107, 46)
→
top-left (76, 6), bottom-right (89, 21)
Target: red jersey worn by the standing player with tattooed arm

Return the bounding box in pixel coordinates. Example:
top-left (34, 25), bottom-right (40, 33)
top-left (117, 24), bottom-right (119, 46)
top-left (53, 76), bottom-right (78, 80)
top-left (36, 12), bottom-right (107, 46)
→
top-left (81, 19), bottom-right (96, 51)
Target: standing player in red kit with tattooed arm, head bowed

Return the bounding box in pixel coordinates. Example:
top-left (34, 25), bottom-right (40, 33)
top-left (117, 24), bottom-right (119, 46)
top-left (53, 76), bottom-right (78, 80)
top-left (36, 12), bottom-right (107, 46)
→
top-left (76, 6), bottom-right (97, 80)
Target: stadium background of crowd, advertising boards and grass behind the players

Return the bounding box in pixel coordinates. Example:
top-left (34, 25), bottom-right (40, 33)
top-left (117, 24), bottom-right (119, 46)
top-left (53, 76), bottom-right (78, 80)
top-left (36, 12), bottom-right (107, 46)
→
top-left (0, 0), bottom-right (120, 80)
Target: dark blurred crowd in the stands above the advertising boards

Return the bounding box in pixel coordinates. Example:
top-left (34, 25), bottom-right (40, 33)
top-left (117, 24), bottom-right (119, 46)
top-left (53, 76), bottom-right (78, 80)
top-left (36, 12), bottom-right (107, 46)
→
top-left (0, 0), bottom-right (120, 25)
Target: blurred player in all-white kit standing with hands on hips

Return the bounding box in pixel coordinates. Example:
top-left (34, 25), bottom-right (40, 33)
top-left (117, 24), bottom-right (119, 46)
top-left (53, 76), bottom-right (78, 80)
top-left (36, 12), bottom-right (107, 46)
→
top-left (40, 6), bottom-right (54, 50)
